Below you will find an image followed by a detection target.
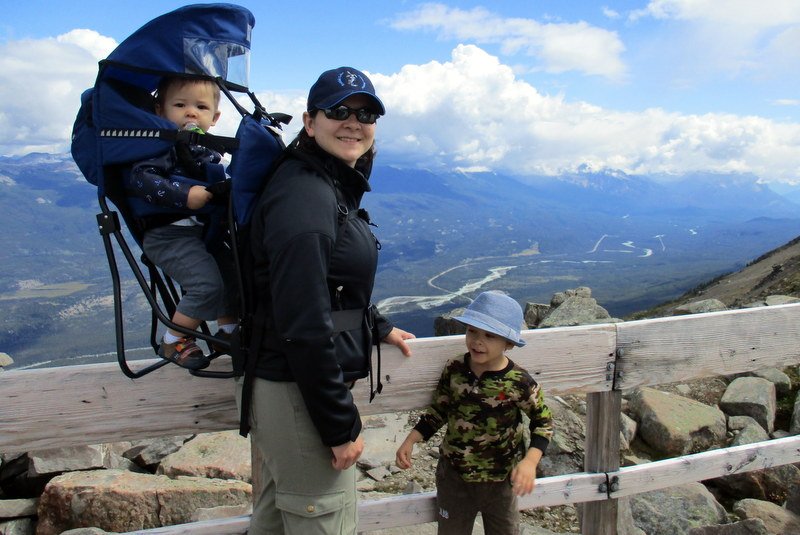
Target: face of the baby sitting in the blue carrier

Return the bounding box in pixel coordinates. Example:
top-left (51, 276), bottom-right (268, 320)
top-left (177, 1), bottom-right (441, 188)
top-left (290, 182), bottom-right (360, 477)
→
top-left (156, 82), bottom-right (220, 132)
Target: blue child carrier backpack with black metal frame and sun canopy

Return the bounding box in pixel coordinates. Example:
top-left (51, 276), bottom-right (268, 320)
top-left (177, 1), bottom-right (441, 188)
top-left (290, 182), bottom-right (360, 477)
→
top-left (71, 4), bottom-right (291, 378)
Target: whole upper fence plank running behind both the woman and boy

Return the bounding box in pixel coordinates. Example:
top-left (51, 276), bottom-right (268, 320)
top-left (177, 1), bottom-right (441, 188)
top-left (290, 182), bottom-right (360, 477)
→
top-left (0, 325), bottom-right (614, 453)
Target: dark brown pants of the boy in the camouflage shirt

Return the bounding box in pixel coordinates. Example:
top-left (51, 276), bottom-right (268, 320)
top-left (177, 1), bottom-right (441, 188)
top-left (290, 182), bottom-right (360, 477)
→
top-left (436, 457), bottom-right (519, 535)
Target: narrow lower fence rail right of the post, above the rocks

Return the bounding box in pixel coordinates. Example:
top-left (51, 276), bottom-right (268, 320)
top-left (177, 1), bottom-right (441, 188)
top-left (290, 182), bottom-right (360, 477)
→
top-left (609, 436), bottom-right (800, 498)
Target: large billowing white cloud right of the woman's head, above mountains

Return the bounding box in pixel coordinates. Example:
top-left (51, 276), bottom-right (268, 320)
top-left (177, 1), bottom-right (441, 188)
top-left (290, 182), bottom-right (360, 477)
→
top-left (372, 45), bottom-right (800, 181)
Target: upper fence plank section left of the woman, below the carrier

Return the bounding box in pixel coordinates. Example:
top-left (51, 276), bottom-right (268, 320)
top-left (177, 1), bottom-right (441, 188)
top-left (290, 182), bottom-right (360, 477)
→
top-left (0, 359), bottom-right (237, 453)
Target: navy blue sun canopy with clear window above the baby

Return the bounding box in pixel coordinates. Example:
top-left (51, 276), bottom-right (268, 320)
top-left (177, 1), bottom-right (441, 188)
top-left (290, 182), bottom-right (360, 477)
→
top-left (100, 4), bottom-right (255, 91)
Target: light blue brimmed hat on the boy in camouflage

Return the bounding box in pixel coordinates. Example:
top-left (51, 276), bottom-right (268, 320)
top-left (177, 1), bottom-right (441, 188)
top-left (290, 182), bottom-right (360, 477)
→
top-left (453, 292), bottom-right (525, 347)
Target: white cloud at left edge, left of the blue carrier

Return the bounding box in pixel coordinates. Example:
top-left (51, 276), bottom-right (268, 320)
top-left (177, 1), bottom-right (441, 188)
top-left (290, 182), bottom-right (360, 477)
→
top-left (0, 30), bottom-right (115, 155)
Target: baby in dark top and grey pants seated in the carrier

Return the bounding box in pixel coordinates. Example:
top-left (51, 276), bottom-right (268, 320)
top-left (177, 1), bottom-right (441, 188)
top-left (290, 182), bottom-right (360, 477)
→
top-left (125, 77), bottom-right (237, 370)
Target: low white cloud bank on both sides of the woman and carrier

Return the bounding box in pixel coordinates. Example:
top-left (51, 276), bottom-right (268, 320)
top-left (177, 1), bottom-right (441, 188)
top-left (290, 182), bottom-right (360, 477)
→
top-left (0, 30), bottom-right (800, 185)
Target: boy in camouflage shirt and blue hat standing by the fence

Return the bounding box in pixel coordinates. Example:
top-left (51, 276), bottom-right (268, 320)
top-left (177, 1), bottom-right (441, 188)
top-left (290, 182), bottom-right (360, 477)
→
top-left (396, 292), bottom-right (553, 535)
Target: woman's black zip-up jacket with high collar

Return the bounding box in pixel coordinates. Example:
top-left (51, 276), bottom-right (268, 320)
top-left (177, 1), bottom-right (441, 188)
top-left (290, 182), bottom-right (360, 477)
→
top-left (251, 148), bottom-right (392, 446)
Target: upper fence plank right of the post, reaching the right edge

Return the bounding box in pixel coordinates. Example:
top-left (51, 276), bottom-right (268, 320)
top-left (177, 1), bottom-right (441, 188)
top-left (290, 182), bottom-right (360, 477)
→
top-left (617, 304), bottom-right (800, 390)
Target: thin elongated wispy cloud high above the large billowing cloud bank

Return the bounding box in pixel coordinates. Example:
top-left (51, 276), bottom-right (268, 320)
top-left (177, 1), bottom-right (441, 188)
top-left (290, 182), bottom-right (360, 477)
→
top-left (391, 4), bottom-right (626, 80)
